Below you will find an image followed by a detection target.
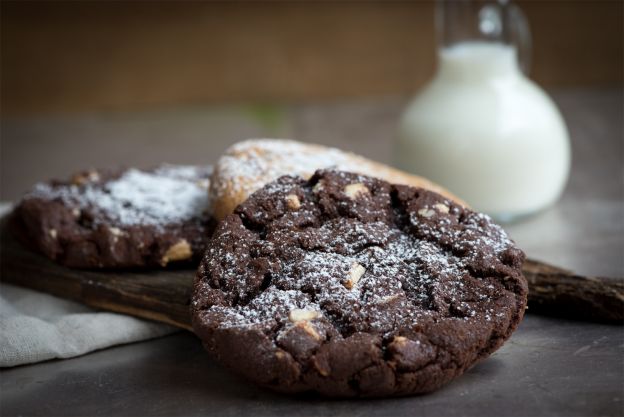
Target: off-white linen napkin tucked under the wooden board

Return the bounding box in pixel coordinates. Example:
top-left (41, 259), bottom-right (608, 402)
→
top-left (0, 204), bottom-right (178, 367)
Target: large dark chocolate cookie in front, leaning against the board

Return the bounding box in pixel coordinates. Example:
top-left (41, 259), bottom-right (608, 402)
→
top-left (192, 171), bottom-right (527, 397)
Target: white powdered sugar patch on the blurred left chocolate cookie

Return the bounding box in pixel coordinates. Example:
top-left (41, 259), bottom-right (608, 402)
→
top-left (25, 165), bottom-right (209, 227)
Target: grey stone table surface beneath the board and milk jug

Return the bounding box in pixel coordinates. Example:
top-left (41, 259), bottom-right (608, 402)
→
top-left (0, 88), bottom-right (624, 416)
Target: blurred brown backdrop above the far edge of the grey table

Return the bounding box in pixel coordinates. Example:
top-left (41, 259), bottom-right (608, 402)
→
top-left (2, 1), bottom-right (624, 116)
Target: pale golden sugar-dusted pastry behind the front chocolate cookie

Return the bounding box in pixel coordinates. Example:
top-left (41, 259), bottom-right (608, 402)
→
top-left (209, 139), bottom-right (466, 220)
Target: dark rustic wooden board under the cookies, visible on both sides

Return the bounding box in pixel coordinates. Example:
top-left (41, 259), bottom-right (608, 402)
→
top-left (0, 214), bottom-right (624, 330)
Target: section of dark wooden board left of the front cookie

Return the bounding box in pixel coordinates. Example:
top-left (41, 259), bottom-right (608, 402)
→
top-left (0, 216), bottom-right (195, 330)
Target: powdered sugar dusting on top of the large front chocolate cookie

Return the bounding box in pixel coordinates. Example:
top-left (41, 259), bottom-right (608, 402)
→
top-left (199, 173), bottom-right (517, 335)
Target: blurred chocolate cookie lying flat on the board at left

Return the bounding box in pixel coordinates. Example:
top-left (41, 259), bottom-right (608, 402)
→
top-left (11, 165), bottom-right (215, 268)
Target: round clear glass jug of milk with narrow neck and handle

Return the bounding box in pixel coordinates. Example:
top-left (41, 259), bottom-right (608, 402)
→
top-left (394, 0), bottom-right (570, 221)
